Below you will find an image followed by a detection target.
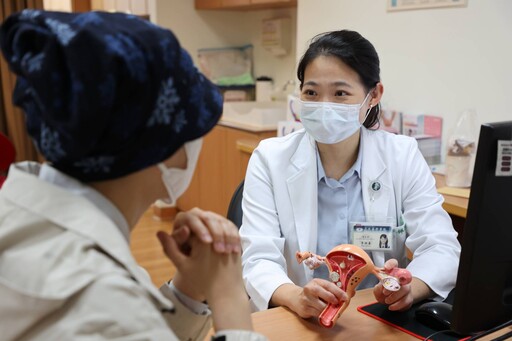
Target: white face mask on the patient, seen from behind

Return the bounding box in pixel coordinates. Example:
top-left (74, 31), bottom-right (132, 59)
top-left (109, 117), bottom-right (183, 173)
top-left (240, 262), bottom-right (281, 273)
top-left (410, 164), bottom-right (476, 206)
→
top-left (158, 138), bottom-right (203, 205)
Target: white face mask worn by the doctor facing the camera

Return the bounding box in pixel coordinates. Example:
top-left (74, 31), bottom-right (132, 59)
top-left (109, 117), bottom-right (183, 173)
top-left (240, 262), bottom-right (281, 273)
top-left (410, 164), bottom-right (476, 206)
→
top-left (300, 93), bottom-right (371, 144)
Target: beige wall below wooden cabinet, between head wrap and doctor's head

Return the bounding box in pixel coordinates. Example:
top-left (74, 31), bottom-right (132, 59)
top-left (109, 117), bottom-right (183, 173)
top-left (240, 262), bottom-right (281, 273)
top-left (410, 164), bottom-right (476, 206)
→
top-left (148, 0), bottom-right (297, 93)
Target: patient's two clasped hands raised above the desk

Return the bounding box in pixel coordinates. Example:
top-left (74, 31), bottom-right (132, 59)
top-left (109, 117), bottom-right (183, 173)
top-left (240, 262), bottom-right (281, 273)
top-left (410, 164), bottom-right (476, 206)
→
top-left (157, 208), bottom-right (243, 305)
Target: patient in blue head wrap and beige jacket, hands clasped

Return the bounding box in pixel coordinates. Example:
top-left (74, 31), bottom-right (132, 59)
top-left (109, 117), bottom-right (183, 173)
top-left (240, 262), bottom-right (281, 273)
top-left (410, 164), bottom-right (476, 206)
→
top-left (0, 10), bottom-right (265, 340)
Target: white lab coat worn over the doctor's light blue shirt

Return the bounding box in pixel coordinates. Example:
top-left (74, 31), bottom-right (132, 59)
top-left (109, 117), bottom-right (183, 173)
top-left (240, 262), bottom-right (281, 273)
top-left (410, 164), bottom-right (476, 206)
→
top-left (240, 128), bottom-right (460, 310)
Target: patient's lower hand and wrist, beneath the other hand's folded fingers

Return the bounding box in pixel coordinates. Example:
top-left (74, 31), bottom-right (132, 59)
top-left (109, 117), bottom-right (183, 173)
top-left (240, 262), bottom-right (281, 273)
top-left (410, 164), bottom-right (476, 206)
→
top-left (158, 232), bottom-right (252, 331)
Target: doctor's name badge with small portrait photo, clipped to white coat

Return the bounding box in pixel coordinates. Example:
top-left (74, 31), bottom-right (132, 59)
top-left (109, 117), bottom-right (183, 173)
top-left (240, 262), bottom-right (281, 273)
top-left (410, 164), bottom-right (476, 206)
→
top-left (350, 222), bottom-right (394, 252)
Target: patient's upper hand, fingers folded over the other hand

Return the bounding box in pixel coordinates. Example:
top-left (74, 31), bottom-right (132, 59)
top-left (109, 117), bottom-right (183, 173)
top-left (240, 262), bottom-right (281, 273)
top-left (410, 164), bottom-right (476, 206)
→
top-left (167, 207), bottom-right (241, 253)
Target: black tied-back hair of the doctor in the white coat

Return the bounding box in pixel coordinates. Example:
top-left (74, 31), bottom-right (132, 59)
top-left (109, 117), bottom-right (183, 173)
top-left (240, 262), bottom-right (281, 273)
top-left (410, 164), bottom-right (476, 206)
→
top-left (297, 30), bottom-right (380, 128)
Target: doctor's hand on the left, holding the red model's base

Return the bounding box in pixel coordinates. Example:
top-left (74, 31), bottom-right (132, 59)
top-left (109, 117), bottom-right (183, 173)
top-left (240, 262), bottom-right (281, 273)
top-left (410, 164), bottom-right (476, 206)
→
top-left (271, 278), bottom-right (348, 318)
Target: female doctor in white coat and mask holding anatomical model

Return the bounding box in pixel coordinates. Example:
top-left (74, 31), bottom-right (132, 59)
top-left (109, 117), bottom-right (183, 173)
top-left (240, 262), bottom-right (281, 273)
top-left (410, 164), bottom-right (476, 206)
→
top-left (240, 30), bottom-right (460, 318)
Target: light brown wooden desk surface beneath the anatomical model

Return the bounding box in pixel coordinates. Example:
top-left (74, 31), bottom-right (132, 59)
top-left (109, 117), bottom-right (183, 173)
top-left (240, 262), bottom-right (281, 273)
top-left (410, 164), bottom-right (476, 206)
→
top-left (228, 289), bottom-right (512, 341)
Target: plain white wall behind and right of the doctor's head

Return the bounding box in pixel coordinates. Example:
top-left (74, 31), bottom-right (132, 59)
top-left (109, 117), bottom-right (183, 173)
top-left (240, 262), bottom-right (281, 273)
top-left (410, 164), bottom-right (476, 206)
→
top-left (297, 0), bottom-right (512, 150)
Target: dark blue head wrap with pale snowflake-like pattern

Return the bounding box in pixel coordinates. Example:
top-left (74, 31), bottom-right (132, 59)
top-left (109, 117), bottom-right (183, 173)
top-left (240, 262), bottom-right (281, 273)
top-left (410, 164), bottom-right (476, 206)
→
top-left (0, 10), bottom-right (222, 182)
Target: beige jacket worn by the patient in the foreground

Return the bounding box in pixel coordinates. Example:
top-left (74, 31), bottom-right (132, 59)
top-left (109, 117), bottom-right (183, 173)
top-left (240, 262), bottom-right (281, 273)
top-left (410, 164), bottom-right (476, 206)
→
top-left (0, 163), bottom-right (264, 340)
